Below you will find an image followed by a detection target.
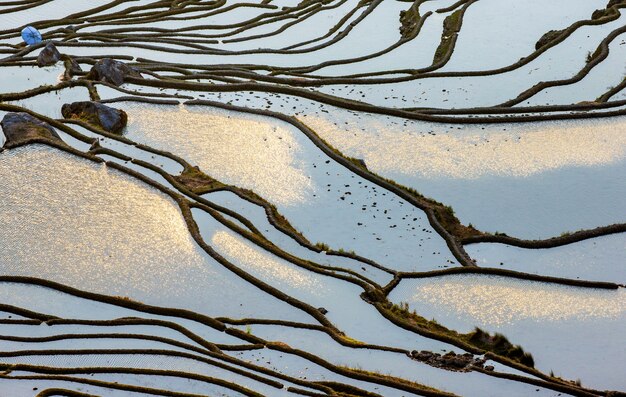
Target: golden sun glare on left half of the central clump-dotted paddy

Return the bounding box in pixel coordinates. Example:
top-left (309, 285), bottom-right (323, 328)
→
top-left (126, 104), bottom-right (313, 204)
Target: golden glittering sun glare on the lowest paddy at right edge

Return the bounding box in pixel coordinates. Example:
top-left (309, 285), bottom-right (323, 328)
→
top-left (392, 276), bottom-right (626, 327)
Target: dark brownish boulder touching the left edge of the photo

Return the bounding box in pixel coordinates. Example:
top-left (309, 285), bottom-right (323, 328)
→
top-left (0, 112), bottom-right (63, 147)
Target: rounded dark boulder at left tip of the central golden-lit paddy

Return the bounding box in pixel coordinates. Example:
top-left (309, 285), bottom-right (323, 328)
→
top-left (61, 101), bottom-right (128, 134)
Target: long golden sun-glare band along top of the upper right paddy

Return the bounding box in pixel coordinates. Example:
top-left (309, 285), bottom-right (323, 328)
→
top-left (304, 109), bottom-right (626, 179)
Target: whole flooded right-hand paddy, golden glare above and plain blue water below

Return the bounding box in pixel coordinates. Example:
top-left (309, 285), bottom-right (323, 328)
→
top-left (304, 109), bottom-right (626, 238)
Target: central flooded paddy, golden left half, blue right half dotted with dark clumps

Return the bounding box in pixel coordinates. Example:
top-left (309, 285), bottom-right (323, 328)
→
top-left (127, 100), bottom-right (456, 270)
